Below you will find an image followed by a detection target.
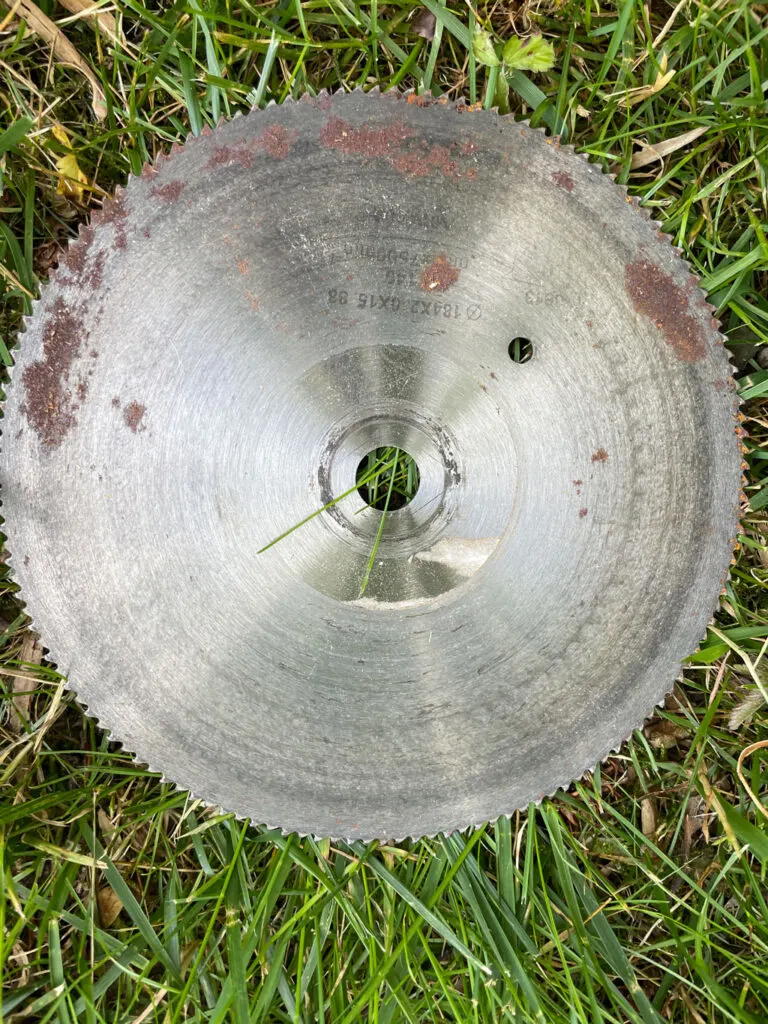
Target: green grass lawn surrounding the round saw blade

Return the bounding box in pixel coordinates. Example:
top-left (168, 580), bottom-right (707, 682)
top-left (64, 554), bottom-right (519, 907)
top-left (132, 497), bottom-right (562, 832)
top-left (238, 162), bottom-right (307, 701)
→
top-left (0, 0), bottom-right (768, 1024)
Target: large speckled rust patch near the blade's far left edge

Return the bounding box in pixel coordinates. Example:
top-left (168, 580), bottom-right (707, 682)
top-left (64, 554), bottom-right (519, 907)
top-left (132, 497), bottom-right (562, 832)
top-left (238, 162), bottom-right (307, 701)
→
top-left (22, 298), bottom-right (88, 449)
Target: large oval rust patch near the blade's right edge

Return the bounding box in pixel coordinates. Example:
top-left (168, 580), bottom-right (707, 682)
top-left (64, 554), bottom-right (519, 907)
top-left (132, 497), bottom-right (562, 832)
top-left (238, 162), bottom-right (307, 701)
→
top-left (625, 260), bottom-right (707, 362)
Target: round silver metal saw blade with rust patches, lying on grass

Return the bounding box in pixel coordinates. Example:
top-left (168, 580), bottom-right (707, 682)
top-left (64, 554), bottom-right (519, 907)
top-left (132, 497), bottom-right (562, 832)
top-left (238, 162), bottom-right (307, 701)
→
top-left (0, 93), bottom-right (740, 839)
